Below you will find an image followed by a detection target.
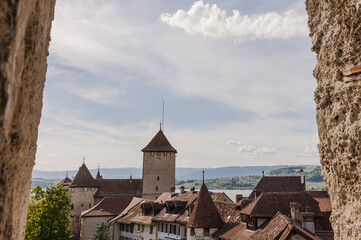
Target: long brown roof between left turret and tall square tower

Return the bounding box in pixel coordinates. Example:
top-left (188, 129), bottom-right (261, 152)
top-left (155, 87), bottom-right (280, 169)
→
top-left (95, 179), bottom-right (143, 197)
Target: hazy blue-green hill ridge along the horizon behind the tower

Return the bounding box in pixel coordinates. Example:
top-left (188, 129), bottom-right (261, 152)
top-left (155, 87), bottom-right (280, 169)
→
top-left (32, 165), bottom-right (317, 180)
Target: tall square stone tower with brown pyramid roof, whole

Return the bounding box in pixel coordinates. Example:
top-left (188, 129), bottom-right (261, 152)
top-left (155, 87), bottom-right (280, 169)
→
top-left (142, 130), bottom-right (177, 199)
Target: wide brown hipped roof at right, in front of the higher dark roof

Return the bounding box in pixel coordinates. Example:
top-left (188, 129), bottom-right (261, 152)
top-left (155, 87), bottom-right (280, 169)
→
top-left (241, 192), bottom-right (322, 217)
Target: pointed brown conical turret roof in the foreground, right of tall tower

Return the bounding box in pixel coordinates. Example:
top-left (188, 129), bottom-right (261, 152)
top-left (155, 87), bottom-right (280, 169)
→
top-left (187, 184), bottom-right (224, 228)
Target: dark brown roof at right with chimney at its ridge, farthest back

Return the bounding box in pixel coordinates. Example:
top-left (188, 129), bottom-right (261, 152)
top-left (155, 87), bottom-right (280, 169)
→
top-left (249, 176), bottom-right (306, 199)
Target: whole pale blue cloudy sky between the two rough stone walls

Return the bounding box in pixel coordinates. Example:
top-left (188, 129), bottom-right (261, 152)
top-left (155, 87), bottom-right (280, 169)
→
top-left (34, 0), bottom-right (319, 171)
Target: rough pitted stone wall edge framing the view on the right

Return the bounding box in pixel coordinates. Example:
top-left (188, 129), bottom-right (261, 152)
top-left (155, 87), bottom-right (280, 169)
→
top-left (306, 0), bottom-right (361, 239)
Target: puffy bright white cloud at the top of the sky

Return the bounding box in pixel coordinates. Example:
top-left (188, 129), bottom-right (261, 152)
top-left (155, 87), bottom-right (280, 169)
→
top-left (160, 0), bottom-right (308, 40)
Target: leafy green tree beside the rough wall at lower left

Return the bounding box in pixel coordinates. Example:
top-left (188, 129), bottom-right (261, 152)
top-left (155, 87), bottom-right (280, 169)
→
top-left (25, 186), bottom-right (72, 240)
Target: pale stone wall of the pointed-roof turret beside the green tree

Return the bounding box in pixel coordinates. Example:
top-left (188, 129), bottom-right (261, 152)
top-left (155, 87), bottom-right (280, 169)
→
top-left (68, 187), bottom-right (98, 239)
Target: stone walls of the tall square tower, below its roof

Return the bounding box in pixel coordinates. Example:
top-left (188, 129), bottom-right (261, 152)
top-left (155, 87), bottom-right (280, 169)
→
top-left (143, 152), bottom-right (175, 200)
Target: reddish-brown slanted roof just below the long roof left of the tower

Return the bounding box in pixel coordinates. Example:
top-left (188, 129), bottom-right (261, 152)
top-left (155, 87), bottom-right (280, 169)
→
top-left (82, 197), bottom-right (133, 217)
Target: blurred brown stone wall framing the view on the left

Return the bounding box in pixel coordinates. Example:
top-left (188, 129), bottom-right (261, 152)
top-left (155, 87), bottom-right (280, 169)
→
top-left (0, 0), bottom-right (55, 239)
